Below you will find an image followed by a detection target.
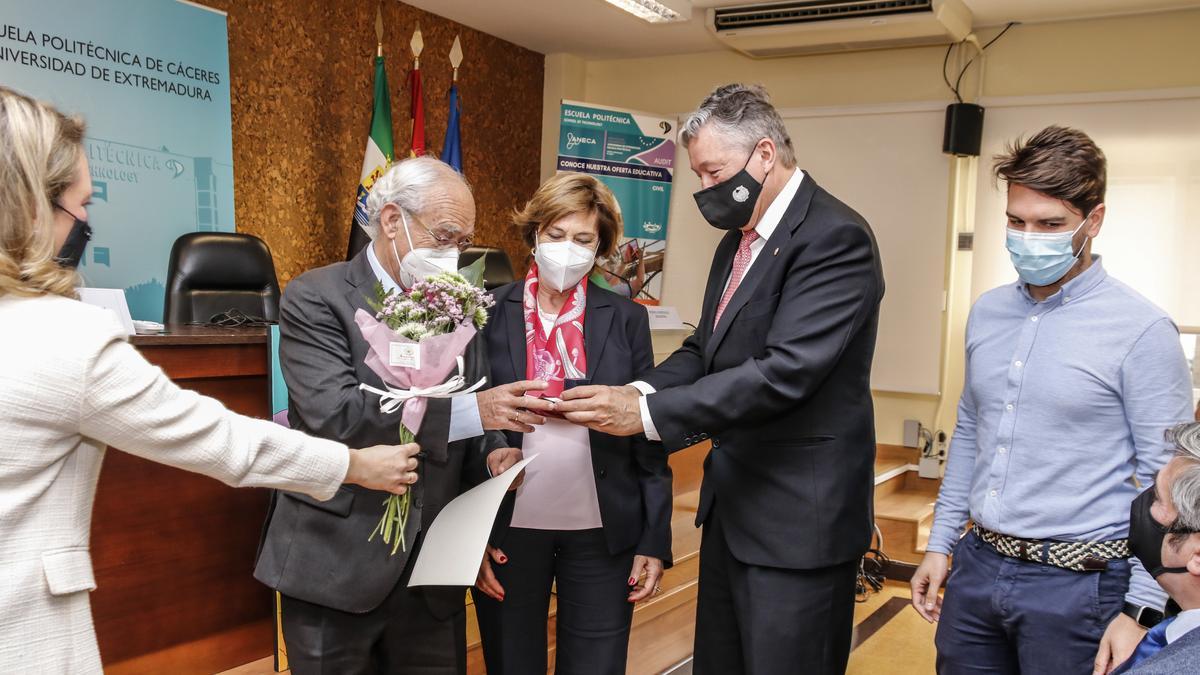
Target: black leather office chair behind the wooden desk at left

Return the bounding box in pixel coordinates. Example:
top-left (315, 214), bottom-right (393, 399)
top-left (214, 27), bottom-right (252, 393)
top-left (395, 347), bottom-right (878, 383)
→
top-left (163, 232), bottom-right (280, 323)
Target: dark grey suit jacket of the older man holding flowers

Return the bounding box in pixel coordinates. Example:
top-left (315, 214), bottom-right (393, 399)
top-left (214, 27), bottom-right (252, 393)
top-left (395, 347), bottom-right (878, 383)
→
top-left (254, 251), bottom-right (504, 617)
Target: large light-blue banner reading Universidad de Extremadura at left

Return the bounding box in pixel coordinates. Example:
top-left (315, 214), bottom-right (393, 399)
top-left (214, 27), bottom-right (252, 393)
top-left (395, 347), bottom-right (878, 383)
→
top-left (0, 0), bottom-right (234, 321)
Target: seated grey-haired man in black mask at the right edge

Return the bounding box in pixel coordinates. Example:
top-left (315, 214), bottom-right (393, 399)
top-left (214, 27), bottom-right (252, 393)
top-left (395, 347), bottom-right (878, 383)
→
top-left (1114, 423), bottom-right (1200, 675)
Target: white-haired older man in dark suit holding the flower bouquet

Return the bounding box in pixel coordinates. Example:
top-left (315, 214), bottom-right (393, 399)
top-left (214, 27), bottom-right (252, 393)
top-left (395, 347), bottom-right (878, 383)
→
top-left (254, 157), bottom-right (554, 675)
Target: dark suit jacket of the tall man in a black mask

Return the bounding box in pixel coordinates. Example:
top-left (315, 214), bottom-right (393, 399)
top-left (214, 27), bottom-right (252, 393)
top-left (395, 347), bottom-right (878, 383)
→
top-left (643, 175), bottom-right (883, 569)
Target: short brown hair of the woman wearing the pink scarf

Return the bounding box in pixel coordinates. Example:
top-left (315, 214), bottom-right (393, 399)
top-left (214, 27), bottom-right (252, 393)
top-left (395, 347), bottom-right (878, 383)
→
top-left (512, 173), bottom-right (622, 257)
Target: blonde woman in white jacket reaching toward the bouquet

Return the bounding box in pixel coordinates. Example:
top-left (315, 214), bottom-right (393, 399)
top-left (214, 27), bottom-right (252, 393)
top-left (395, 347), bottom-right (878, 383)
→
top-left (0, 86), bottom-right (418, 674)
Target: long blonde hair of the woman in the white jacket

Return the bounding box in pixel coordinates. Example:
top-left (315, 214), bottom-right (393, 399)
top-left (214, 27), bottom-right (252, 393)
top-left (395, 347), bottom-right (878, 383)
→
top-left (0, 86), bottom-right (84, 298)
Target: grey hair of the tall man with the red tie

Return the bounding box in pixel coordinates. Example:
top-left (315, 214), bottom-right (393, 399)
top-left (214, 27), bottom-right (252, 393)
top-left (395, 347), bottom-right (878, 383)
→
top-left (679, 84), bottom-right (796, 168)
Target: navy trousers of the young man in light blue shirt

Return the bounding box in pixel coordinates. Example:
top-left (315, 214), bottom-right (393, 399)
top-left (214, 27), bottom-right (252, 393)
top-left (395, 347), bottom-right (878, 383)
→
top-left (936, 530), bottom-right (1129, 675)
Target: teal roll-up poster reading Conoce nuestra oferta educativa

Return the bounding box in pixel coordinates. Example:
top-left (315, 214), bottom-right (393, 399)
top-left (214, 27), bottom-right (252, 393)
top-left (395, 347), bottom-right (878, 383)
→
top-left (558, 101), bottom-right (676, 304)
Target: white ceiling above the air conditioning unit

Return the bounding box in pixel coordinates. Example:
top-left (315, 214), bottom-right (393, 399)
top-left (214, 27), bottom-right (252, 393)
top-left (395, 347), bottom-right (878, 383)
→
top-left (403, 0), bottom-right (1200, 59)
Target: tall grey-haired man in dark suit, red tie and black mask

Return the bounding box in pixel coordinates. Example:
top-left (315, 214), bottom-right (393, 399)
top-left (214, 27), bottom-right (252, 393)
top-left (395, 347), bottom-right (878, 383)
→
top-left (558, 84), bottom-right (883, 675)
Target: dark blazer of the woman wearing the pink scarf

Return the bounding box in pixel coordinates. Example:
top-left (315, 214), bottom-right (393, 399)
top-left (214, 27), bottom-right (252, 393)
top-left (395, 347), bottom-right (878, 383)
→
top-left (484, 279), bottom-right (671, 567)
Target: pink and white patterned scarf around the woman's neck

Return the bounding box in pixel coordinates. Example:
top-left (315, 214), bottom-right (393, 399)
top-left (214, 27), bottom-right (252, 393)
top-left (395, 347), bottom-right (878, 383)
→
top-left (523, 263), bottom-right (588, 398)
